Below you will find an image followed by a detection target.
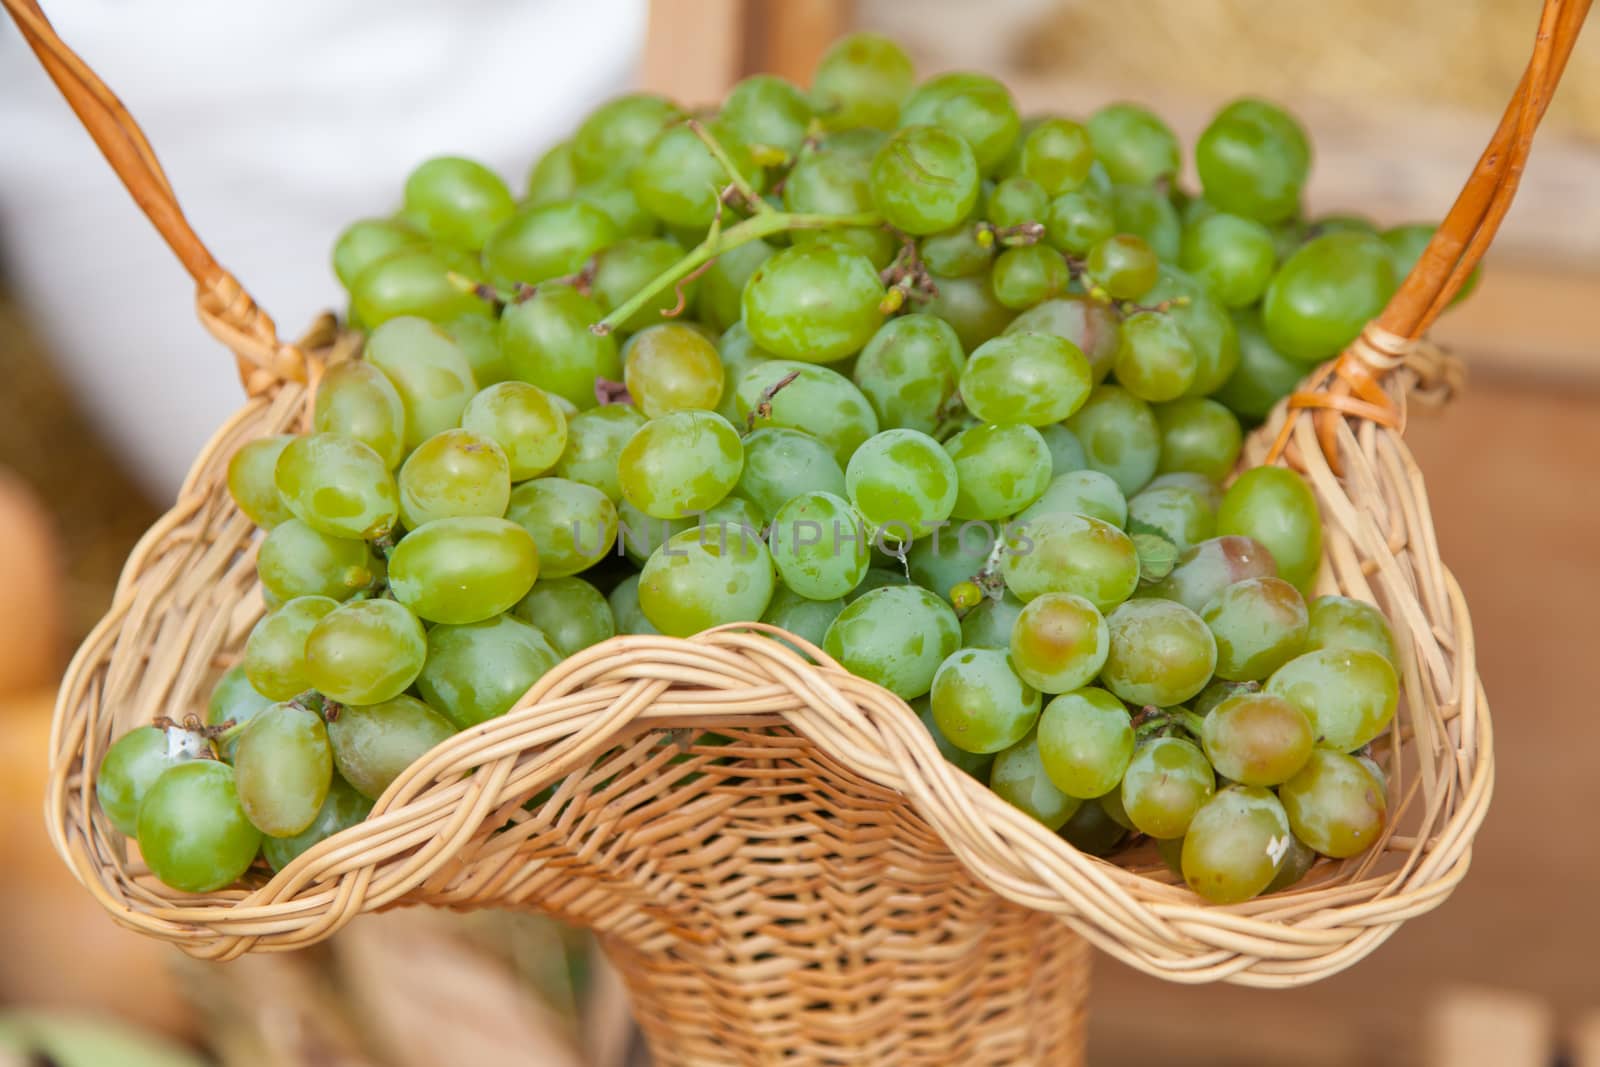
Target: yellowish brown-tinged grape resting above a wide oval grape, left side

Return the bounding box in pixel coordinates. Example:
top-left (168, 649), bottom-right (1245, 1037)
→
top-left (400, 425), bottom-right (510, 530)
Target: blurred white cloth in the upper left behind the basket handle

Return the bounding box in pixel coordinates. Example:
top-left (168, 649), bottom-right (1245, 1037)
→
top-left (0, 0), bottom-right (645, 499)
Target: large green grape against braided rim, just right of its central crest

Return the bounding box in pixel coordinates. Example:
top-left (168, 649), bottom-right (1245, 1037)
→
top-left (822, 585), bottom-right (962, 701)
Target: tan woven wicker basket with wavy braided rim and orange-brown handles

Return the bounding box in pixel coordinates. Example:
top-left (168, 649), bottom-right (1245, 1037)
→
top-left (12, 0), bottom-right (1589, 1065)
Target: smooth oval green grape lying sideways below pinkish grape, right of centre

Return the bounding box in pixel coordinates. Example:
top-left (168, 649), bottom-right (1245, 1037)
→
top-left (962, 333), bottom-right (1091, 426)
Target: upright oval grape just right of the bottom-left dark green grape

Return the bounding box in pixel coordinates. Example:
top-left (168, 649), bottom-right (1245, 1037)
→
top-left (234, 704), bottom-right (333, 837)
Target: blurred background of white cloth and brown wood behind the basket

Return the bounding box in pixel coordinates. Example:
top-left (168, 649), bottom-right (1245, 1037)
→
top-left (0, 0), bottom-right (1600, 1067)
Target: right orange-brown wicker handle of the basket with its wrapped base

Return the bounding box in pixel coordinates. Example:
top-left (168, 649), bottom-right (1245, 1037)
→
top-left (1267, 0), bottom-right (1590, 472)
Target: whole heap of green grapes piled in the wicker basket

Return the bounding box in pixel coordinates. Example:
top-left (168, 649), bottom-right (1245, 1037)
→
top-left (98, 34), bottom-right (1429, 901)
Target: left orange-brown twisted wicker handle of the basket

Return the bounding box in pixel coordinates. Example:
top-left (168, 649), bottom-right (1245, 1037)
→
top-left (0, 0), bottom-right (307, 397)
